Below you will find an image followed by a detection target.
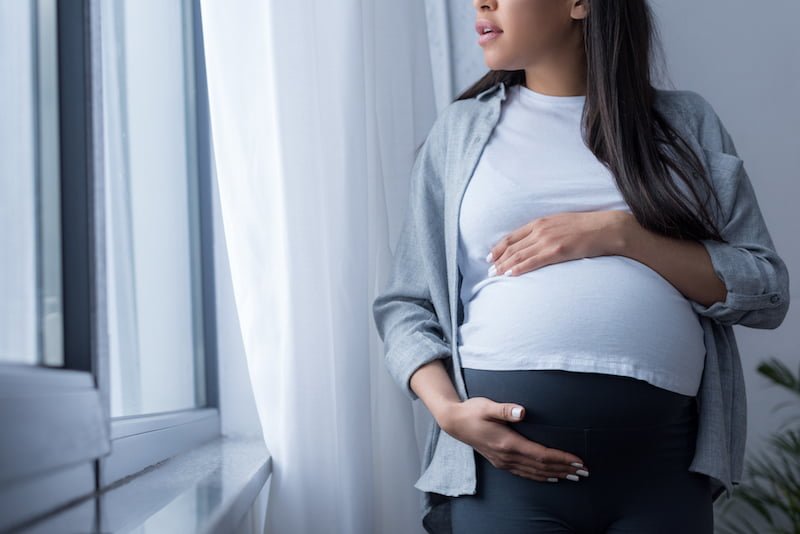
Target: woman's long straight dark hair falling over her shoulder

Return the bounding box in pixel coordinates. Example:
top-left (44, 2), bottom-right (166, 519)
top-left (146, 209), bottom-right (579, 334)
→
top-left (438, 0), bottom-right (725, 242)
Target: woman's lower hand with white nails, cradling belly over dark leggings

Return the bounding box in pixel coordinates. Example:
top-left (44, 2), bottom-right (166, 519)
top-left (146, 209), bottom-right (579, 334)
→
top-left (437, 397), bottom-right (589, 482)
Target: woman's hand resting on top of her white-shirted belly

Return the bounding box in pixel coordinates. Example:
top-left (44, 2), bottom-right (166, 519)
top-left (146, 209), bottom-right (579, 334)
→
top-left (489, 210), bottom-right (638, 276)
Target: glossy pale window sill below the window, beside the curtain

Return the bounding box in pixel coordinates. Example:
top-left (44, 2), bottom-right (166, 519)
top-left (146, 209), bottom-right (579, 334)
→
top-left (18, 437), bottom-right (272, 534)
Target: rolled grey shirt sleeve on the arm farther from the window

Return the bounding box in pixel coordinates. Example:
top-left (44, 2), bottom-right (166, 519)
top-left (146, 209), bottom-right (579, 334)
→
top-left (690, 99), bottom-right (789, 329)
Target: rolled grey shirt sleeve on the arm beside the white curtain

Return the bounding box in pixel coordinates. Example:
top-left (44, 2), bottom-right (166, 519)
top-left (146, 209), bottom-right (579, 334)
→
top-left (372, 111), bottom-right (452, 400)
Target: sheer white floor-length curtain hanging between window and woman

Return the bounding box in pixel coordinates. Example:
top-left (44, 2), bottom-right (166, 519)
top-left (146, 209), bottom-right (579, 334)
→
top-left (201, 0), bottom-right (436, 533)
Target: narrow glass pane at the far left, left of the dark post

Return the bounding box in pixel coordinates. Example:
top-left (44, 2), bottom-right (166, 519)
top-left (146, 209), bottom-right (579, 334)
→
top-left (0, 0), bottom-right (64, 366)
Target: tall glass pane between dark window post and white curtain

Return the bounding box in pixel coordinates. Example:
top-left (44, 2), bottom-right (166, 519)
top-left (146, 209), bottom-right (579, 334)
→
top-left (101, 0), bottom-right (205, 417)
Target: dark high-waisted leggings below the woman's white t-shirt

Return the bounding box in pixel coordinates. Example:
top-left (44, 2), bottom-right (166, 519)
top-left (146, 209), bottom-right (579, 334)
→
top-left (450, 369), bottom-right (714, 534)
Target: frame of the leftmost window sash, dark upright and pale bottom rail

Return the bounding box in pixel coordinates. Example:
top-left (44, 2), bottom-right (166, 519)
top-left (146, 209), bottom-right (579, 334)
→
top-left (0, 2), bottom-right (111, 529)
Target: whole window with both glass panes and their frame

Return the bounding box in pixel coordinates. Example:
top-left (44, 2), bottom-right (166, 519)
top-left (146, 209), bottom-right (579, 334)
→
top-left (0, 0), bottom-right (219, 530)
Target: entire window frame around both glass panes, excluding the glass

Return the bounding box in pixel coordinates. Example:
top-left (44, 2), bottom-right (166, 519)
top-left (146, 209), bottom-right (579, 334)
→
top-left (0, 0), bottom-right (221, 530)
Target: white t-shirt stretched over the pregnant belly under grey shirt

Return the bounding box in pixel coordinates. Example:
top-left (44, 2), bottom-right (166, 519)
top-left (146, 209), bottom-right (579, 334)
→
top-left (458, 85), bottom-right (706, 396)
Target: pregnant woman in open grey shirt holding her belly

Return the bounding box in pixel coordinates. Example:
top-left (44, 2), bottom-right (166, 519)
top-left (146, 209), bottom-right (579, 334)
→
top-left (374, 0), bottom-right (788, 534)
